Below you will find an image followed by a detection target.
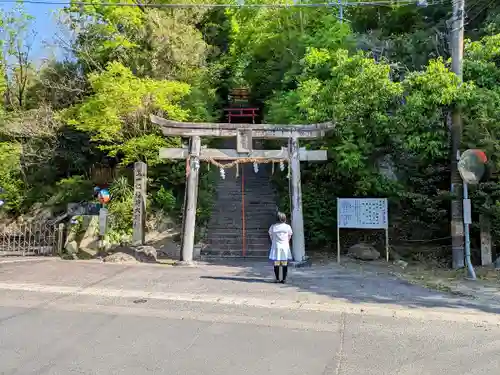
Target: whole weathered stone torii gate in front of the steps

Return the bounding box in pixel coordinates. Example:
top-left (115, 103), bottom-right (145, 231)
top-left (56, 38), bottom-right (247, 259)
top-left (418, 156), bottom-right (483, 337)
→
top-left (150, 115), bottom-right (334, 263)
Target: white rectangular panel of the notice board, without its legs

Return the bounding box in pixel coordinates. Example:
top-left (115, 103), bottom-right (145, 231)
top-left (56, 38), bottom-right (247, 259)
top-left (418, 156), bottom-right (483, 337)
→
top-left (337, 198), bottom-right (389, 229)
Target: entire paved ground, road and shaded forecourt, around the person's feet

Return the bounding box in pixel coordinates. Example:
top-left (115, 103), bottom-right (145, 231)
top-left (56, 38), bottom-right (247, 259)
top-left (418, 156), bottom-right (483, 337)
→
top-left (0, 261), bottom-right (500, 375)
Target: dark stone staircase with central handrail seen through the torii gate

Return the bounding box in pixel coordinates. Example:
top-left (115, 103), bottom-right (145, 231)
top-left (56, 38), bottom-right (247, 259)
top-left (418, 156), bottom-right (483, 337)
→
top-left (201, 157), bottom-right (276, 259)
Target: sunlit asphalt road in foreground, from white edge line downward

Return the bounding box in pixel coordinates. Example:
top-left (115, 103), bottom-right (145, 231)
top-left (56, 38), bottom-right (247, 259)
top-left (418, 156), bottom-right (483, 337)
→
top-left (0, 290), bottom-right (500, 375)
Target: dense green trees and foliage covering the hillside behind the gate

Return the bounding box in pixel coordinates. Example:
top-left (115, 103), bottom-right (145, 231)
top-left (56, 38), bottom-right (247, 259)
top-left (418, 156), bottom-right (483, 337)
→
top-left (0, 0), bottom-right (500, 258)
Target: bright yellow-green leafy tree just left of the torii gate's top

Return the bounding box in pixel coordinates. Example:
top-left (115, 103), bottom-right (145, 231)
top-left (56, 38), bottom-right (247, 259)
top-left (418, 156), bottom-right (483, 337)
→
top-left (62, 63), bottom-right (190, 165)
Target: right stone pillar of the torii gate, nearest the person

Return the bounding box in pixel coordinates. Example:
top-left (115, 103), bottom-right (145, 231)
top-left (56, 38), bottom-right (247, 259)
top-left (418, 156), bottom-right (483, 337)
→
top-left (289, 137), bottom-right (306, 262)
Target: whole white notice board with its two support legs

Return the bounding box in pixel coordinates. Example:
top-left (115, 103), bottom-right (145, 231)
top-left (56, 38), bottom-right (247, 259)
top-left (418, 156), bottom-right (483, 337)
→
top-left (337, 198), bottom-right (389, 263)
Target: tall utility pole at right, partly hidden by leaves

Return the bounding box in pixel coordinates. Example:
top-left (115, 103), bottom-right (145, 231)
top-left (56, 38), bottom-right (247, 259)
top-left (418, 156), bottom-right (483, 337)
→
top-left (450, 0), bottom-right (465, 269)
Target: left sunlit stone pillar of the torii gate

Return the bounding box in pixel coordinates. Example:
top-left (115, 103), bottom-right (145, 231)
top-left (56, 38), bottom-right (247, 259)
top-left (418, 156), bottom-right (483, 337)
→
top-left (181, 136), bottom-right (201, 263)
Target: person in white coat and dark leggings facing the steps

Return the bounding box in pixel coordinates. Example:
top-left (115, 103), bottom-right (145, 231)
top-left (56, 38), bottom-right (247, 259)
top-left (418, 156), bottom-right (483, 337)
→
top-left (269, 212), bottom-right (293, 284)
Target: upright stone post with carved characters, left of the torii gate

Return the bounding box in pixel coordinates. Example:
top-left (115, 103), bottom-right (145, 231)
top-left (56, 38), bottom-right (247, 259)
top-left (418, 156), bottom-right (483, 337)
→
top-left (132, 162), bottom-right (148, 246)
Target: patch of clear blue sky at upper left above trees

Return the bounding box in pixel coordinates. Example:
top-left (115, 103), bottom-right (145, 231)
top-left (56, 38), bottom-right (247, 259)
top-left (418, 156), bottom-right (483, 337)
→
top-left (0, 2), bottom-right (63, 62)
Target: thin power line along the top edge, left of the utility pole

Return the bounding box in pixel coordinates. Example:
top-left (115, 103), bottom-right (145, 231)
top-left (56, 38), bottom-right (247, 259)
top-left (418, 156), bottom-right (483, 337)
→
top-left (0, 0), bottom-right (449, 9)
